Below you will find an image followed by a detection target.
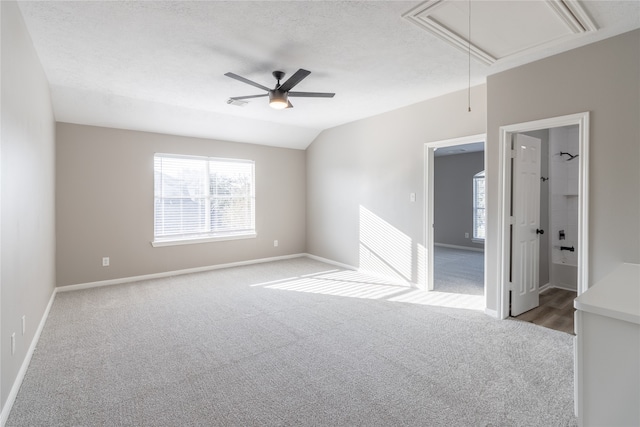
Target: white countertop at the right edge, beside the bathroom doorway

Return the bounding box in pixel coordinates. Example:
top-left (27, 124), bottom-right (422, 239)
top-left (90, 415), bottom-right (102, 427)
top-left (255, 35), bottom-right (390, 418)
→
top-left (573, 264), bottom-right (640, 325)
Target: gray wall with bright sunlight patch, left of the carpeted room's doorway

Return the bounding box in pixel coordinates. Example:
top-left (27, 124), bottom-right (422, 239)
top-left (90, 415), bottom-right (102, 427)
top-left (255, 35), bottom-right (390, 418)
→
top-left (307, 86), bottom-right (486, 283)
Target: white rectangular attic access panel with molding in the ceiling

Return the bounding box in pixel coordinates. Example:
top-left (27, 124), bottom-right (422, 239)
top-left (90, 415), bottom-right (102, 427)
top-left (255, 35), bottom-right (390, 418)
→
top-left (403, 0), bottom-right (597, 65)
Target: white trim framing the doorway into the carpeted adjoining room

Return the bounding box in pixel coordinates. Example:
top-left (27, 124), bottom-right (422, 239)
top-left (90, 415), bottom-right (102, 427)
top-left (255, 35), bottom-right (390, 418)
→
top-left (424, 133), bottom-right (487, 300)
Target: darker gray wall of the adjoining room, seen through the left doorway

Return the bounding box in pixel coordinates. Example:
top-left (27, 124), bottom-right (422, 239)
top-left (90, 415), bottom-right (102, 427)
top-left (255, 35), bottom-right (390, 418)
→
top-left (433, 151), bottom-right (484, 249)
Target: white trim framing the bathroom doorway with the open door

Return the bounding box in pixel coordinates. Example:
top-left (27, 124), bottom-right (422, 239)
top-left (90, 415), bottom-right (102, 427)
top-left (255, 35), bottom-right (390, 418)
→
top-left (498, 111), bottom-right (589, 319)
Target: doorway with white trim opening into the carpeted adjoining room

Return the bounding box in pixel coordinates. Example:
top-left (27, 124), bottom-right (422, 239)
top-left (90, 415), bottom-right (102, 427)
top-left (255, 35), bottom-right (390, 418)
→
top-left (425, 134), bottom-right (486, 306)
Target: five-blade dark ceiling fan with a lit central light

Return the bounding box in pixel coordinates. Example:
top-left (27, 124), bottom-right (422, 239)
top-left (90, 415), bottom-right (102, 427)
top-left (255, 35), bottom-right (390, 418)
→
top-left (225, 68), bottom-right (335, 110)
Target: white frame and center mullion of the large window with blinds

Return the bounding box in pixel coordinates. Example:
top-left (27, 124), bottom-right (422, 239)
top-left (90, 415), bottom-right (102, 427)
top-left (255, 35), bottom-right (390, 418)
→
top-left (151, 153), bottom-right (257, 247)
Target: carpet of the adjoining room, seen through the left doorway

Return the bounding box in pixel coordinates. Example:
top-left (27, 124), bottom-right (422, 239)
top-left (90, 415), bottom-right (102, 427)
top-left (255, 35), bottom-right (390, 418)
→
top-left (433, 246), bottom-right (484, 295)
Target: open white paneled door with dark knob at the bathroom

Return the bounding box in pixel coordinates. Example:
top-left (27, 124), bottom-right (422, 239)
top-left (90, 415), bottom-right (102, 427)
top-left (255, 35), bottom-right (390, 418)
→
top-left (511, 134), bottom-right (543, 316)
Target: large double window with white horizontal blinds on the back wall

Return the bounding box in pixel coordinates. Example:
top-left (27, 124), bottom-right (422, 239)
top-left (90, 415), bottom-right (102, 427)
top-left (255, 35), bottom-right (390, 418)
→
top-left (153, 154), bottom-right (256, 246)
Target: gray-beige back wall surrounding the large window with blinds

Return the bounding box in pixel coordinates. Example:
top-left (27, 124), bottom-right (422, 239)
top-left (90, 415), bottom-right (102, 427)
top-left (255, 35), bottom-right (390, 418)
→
top-left (56, 123), bottom-right (306, 286)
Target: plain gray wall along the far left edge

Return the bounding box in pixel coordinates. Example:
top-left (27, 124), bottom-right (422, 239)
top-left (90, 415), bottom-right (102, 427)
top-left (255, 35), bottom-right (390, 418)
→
top-left (0, 1), bottom-right (55, 407)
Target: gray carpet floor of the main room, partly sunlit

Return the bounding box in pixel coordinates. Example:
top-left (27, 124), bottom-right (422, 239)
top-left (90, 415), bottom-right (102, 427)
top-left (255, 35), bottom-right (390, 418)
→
top-left (6, 258), bottom-right (577, 426)
